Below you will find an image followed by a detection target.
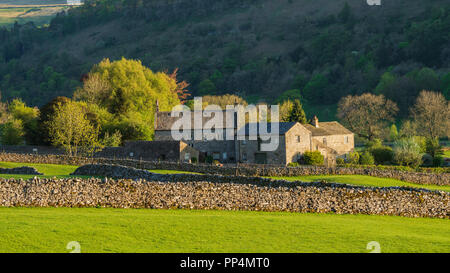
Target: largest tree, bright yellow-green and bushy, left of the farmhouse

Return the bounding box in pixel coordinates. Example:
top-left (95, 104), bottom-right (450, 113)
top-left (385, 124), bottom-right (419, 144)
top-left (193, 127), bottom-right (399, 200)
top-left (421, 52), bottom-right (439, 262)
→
top-left (76, 58), bottom-right (180, 140)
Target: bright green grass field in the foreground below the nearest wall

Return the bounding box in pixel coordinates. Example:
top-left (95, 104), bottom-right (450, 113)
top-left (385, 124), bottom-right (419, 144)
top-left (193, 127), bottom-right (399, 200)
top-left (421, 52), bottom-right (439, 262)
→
top-left (0, 208), bottom-right (450, 253)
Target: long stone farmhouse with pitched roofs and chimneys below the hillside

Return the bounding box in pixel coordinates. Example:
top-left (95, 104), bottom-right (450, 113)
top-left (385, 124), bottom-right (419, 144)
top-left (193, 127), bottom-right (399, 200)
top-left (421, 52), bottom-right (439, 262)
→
top-left (154, 110), bottom-right (354, 166)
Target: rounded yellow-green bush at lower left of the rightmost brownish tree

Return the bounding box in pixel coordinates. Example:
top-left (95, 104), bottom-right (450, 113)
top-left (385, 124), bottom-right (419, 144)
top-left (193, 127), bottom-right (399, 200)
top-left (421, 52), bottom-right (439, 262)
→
top-left (393, 138), bottom-right (423, 168)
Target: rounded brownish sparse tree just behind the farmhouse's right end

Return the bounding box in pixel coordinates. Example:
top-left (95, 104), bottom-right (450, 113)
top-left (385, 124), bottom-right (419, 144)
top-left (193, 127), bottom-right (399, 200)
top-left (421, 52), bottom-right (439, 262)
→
top-left (337, 93), bottom-right (398, 140)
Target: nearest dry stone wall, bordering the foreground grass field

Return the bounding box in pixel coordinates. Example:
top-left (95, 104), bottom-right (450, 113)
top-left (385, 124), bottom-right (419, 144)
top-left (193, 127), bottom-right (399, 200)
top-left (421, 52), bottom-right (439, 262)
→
top-left (0, 169), bottom-right (450, 219)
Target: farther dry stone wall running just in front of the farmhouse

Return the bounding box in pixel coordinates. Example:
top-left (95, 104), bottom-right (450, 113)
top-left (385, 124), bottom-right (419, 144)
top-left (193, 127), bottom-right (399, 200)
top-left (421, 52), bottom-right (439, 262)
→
top-left (0, 153), bottom-right (450, 186)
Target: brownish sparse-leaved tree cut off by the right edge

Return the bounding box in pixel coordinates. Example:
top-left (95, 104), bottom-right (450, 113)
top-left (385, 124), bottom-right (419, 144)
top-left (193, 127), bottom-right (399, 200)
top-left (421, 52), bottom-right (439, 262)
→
top-left (410, 90), bottom-right (450, 139)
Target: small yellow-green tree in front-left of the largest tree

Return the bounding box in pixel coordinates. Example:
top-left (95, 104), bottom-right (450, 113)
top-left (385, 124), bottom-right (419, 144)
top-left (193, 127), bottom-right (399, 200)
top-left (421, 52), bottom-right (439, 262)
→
top-left (47, 101), bottom-right (100, 156)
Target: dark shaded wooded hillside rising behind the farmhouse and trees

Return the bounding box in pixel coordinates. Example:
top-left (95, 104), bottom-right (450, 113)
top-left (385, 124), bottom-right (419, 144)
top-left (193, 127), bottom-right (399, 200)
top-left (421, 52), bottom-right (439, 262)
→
top-left (0, 0), bottom-right (450, 119)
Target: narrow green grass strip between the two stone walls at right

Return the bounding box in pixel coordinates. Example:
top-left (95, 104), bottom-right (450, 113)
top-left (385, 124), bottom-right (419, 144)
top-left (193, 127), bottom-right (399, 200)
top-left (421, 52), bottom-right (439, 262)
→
top-left (271, 175), bottom-right (450, 192)
